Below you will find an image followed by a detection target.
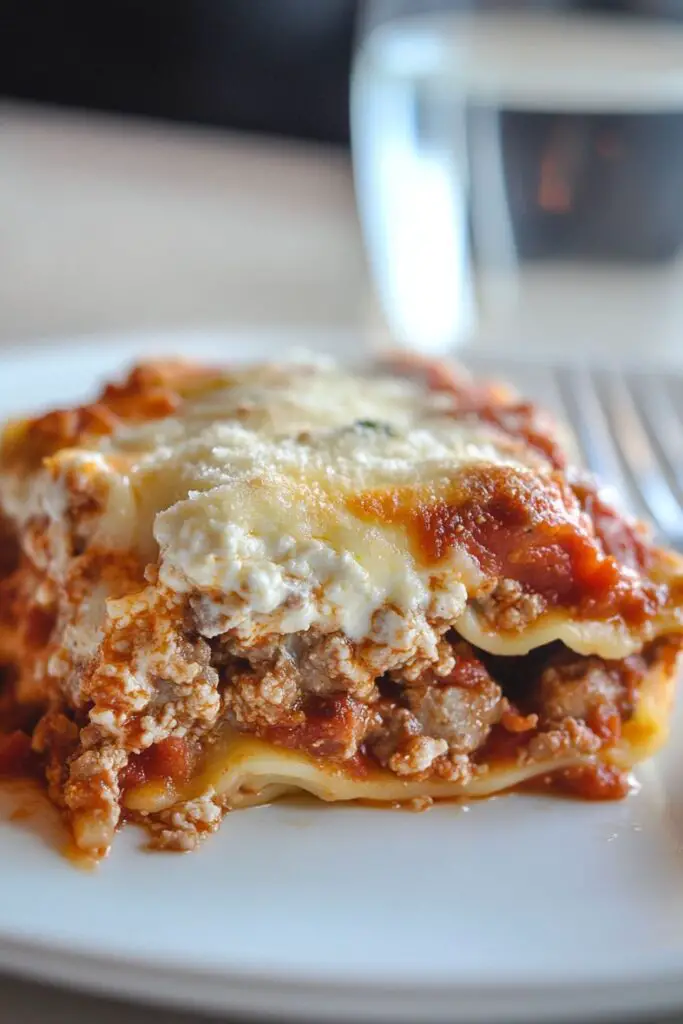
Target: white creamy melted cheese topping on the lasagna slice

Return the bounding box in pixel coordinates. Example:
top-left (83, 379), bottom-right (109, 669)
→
top-left (31, 365), bottom-right (547, 642)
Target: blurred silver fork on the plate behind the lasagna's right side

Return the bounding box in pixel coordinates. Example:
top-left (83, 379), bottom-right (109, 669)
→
top-left (466, 356), bottom-right (683, 551)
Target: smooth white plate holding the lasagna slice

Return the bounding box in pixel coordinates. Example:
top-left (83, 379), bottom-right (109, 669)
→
top-left (0, 336), bottom-right (683, 1022)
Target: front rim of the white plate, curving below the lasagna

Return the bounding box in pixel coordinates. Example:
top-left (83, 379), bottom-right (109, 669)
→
top-left (0, 936), bottom-right (683, 1024)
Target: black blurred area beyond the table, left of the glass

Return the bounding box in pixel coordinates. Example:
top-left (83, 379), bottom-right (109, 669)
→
top-left (0, 0), bottom-right (358, 145)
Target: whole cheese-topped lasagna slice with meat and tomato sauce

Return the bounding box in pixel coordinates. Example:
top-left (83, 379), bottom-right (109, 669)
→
top-left (0, 352), bottom-right (683, 857)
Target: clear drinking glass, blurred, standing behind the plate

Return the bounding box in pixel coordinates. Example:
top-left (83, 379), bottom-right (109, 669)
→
top-left (351, 0), bottom-right (683, 358)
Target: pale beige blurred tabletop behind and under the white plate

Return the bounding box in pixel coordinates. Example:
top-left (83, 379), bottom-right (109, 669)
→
top-left (0, 97), bottom-right (683, 1024)
